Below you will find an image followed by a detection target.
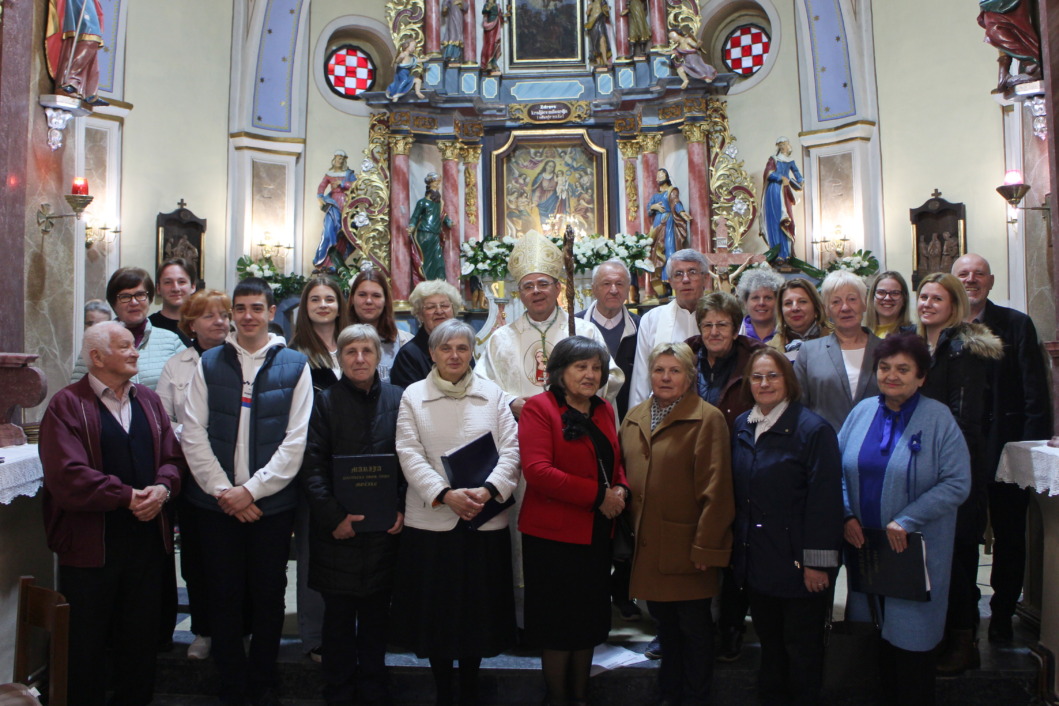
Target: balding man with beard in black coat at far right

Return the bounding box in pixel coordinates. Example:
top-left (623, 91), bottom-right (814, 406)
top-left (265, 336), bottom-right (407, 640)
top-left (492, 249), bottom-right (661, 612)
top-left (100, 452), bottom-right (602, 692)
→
top-left (952, 253), bottom-right (1052, 641)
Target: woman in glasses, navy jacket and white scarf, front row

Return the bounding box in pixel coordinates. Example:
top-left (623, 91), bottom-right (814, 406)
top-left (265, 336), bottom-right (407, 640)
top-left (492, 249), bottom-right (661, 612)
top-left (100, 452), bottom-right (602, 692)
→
top-left (732, 348), bottom-right (843, 704)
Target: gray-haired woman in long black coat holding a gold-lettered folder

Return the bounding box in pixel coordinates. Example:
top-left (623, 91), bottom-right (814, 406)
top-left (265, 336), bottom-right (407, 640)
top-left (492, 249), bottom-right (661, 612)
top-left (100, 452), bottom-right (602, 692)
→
top-left (298, 324), bottom-right (405, 705)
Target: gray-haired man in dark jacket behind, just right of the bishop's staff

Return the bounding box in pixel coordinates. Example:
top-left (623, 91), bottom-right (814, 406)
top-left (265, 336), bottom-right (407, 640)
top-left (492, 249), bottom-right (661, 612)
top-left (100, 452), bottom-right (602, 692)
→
top-left (575, 259), bottom-right (641, 620)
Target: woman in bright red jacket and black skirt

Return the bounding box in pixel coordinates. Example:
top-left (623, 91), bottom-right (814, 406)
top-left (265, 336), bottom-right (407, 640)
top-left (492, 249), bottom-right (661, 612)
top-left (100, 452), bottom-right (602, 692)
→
top-left (519, 336), bottom-right (629, 706)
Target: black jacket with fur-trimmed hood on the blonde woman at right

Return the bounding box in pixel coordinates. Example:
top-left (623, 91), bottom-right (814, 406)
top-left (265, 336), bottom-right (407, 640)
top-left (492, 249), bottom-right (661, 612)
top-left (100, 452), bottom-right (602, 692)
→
top-left (921, 323), bottom-right (1004, 496)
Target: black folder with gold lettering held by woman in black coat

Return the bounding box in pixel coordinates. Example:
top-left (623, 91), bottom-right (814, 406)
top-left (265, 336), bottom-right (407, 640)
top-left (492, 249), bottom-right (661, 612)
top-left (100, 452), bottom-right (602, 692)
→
top-left (331, 453), bottom-right (400, 532)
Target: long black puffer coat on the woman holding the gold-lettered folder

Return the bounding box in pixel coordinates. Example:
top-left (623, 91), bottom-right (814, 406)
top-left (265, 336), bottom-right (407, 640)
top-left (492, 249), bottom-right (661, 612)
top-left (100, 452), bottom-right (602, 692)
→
top-left (298, 374), bottom-right (407, 597)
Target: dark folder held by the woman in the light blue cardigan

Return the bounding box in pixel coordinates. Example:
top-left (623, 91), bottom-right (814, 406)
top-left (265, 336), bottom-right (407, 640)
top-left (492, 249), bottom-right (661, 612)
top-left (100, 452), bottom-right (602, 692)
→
top-left (845, 527), bottom-right (930, 601)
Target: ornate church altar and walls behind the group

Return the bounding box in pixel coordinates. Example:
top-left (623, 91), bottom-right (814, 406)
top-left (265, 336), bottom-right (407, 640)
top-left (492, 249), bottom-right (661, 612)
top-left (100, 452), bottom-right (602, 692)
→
top-left (0, 0), bottom-right (1059, 699)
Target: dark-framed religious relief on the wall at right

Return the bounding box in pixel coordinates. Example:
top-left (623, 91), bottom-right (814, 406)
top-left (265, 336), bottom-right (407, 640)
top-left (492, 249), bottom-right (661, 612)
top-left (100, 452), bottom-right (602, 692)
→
top-left (909, 189), bottom-right (967, 290)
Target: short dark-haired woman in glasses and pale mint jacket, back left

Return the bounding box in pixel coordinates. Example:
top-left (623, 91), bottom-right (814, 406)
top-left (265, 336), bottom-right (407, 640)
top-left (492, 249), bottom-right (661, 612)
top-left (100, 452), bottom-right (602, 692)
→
top-left (71, 267), bottom-right (186, 390)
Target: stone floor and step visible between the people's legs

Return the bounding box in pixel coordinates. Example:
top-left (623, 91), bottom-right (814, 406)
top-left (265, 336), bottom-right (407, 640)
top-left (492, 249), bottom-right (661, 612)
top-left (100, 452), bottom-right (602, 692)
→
top-left (155, 556), bottom-right (1038, 706)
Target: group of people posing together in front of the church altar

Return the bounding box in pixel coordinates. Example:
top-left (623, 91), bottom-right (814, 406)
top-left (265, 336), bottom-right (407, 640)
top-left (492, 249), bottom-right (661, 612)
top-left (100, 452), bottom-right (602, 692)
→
top-left (40, 233), bottom-right (1051, 706)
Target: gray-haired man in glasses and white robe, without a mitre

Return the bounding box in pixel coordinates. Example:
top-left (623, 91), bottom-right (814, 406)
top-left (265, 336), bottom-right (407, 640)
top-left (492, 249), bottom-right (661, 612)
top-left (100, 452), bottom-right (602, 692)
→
top-left (628, 248), bottom-right (710, 409)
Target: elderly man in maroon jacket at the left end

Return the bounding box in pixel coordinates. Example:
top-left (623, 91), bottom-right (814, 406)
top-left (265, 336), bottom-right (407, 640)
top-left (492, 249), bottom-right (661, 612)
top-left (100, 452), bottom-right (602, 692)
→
top-left (40, 322), bottom-right (186, 706)
